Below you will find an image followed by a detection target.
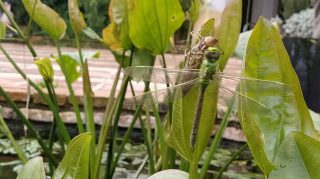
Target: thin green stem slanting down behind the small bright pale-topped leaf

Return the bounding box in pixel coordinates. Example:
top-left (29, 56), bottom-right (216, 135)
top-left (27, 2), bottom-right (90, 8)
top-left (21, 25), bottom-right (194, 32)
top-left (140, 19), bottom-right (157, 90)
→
top-left (56, 41), bottom-right (84, 133)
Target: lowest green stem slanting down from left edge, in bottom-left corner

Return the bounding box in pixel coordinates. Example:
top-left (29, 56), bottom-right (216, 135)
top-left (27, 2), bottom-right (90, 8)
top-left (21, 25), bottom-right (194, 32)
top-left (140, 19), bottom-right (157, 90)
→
top-left (0, 107), bottom-right (28, 164)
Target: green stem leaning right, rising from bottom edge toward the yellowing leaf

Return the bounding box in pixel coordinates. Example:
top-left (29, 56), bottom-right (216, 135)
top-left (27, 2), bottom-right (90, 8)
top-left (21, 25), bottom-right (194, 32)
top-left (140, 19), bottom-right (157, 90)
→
top-left (94, 60), bottom-right (124, 179)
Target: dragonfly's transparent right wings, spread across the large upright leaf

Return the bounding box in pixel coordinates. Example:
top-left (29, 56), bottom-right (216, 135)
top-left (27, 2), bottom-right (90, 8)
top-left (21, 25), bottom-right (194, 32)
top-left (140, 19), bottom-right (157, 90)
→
top-left (213, 73), bottom-right (295, 115)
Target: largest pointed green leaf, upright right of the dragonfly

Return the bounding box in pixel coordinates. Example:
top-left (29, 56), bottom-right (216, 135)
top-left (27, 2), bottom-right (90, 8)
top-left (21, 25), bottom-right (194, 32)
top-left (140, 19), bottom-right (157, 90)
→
top-left (239, 18), bottom-right (315, 175)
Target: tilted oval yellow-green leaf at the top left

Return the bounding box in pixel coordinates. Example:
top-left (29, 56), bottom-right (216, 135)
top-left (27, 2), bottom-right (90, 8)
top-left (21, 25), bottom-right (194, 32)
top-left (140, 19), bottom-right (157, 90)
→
top-left (22, 0), bottom-right (67, 40)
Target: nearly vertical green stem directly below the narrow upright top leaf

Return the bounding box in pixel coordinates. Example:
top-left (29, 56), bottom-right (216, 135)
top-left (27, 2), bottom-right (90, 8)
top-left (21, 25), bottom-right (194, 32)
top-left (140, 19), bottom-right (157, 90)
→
top-left (75, 34), bottom-right (96, 175)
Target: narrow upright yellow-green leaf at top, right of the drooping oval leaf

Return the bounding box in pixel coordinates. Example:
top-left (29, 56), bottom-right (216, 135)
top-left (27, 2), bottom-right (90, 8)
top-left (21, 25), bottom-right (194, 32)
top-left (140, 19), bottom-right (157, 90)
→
top-left (68, 0), bottom-right (87, 35)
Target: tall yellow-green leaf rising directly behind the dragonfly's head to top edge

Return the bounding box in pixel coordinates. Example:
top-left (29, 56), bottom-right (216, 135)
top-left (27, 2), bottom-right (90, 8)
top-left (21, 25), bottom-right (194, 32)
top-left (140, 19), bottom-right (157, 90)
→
top-left (211, 0), bottom-right (242, 71)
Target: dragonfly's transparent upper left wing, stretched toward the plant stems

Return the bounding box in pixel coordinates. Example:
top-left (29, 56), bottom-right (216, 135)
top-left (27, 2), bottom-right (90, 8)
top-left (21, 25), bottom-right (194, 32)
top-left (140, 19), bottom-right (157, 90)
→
top-left (124, 66), bottom-right (202, 85)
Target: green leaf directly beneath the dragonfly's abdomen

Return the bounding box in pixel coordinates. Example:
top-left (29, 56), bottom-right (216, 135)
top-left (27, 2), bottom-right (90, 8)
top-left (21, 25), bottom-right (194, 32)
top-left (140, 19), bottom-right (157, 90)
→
top-left (166, 84), bottom-right (218, 163)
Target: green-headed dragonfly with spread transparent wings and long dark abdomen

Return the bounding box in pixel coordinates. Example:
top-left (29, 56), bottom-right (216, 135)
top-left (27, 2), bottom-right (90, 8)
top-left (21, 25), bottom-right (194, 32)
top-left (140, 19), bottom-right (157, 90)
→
top-left (124, 47), bottom-right (287, 149)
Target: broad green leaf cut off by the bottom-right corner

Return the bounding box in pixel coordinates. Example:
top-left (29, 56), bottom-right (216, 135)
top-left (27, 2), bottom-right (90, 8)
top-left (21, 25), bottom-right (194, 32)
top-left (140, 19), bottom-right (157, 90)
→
top-left (269, 132), bottom-right (320, 179)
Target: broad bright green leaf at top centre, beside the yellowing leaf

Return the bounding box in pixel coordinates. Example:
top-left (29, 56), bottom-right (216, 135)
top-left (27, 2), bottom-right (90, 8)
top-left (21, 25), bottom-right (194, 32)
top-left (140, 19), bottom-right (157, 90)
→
top-left (129, 0), bottom-right (184, 54)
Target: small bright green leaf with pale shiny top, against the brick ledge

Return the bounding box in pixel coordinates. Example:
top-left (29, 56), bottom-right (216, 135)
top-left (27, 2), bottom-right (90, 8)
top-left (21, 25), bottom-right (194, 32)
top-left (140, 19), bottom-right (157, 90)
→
top-left (54, 51), bottom-right (100, 83)
